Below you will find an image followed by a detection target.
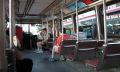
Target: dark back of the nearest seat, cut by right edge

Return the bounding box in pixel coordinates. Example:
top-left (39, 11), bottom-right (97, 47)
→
top-left (103, 43), bottom-right (120, 68)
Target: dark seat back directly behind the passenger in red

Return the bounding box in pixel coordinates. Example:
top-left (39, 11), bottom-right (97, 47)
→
top-left (61, 40), bottom-right (76, 59)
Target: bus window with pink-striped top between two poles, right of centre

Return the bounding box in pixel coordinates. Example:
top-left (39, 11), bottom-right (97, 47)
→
top-left (78, 10), bottom-right (97, 39)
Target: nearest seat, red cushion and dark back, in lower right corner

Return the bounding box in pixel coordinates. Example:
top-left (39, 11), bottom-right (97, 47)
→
top-left (85, 43), bottom-right (120, 70)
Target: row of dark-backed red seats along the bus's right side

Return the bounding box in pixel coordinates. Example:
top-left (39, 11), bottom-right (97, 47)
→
top-left (48, 40), bottom-right (120, 70)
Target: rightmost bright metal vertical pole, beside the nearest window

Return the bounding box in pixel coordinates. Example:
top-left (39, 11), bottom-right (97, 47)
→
top-left (103, 0), bottom-right (107, 45)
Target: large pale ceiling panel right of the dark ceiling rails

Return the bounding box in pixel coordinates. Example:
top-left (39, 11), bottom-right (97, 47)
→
top-left (29, 0), bottom-right (54, 14)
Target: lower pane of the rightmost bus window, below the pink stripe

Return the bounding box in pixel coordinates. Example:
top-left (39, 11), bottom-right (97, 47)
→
top-left (107, 13), bottom-right (120, 38)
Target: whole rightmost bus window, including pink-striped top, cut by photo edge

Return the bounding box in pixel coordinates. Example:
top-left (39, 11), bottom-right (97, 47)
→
top-left (106, 3), bottom-right (120, 38)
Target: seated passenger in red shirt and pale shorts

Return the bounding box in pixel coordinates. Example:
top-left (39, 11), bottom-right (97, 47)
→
top-left (51, 28), bottom-right (72, 59)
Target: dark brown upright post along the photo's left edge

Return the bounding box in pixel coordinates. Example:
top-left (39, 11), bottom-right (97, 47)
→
top-left (0, 0), bottom-right (7, 72)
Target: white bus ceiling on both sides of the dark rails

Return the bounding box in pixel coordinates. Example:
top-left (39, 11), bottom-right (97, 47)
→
top-left (19, 0), bottom-right (54, 14)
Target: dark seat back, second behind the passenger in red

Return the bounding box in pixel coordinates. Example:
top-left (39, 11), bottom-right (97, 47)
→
top-left (76, 41), bottom-right (97, 61)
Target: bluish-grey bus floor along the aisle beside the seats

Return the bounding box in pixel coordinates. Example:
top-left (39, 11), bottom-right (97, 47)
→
top-left (23, 50), bottom-right (120, 72)
